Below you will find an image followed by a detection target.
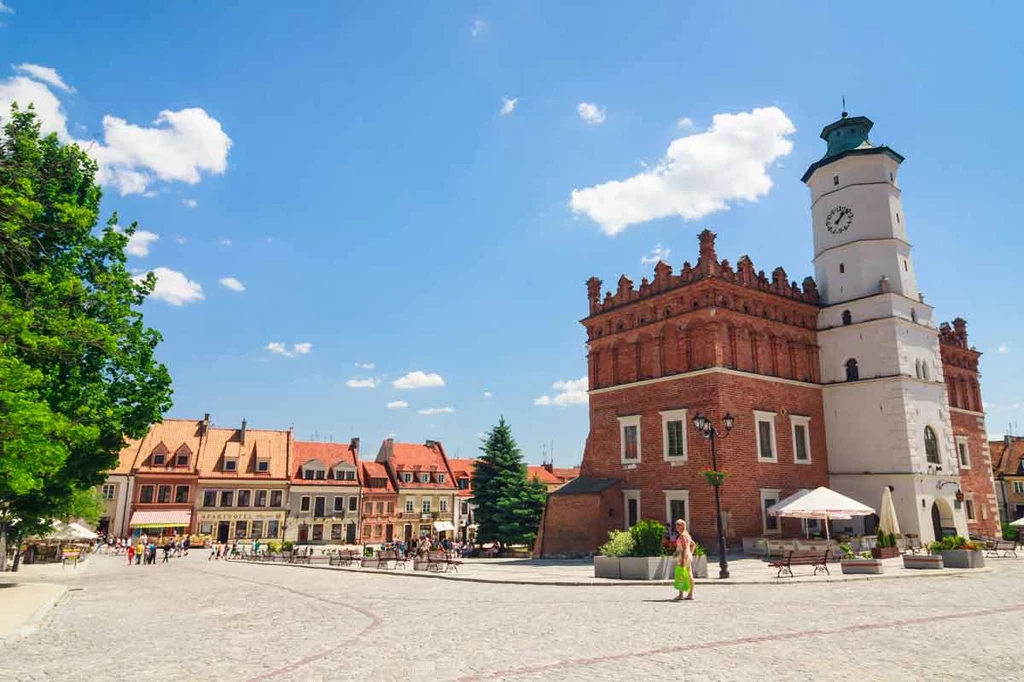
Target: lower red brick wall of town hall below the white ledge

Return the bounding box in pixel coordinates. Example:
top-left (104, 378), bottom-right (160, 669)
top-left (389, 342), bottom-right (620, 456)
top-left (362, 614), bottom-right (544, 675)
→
top-left (581, 370), bottom-right (828, 545)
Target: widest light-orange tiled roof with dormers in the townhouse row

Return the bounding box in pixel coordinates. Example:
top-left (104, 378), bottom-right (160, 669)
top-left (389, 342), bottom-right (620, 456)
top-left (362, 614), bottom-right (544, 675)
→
top-left (200, 427), bottom-right (289, 478)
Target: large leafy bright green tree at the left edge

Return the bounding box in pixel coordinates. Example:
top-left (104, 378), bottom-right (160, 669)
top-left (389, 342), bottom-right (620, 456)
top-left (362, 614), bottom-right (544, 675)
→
top-left (0, 105), bottom-right (171, 569)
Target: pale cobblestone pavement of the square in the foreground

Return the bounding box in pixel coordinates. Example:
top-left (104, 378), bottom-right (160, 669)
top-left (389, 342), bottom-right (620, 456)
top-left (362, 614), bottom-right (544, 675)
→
top-left (8, 554), bottom-right (1024, 682)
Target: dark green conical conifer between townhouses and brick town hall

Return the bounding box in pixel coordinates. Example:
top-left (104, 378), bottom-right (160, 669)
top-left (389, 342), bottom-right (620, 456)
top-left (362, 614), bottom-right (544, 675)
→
top-left (472, 417), bottom-right (547, 547)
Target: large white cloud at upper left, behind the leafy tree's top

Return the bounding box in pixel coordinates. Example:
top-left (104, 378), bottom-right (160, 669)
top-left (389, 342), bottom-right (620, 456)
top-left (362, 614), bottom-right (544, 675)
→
top-left (0, 65), bottom-right (231, 196)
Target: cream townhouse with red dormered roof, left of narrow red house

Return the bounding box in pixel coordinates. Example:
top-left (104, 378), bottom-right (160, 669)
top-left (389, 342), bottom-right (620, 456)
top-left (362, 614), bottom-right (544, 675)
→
top-left (285, 438), bottom-right (361, 545)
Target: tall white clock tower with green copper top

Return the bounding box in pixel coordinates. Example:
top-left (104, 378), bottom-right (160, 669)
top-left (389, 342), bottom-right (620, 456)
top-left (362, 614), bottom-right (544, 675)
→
top-left (802, 112), bottom-right (967, 542)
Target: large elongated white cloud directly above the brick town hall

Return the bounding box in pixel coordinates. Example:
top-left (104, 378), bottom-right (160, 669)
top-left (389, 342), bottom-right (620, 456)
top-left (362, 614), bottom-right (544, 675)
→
top-left (569, 106), bottom-right (796, 236)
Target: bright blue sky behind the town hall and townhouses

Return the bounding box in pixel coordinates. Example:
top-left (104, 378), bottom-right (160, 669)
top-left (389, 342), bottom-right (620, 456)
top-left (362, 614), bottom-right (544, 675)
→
top-left (0, 0), bottom-right (1024, 458)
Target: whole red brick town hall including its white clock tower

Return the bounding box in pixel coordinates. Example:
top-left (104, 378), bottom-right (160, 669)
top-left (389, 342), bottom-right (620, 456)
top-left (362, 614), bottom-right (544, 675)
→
top-left (537, 113), bottom-right (999, 556)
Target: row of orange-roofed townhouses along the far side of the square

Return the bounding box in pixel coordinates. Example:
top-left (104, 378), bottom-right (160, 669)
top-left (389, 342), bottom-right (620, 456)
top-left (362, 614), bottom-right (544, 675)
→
top-left (99, 415), bottom-right (578, 544)
